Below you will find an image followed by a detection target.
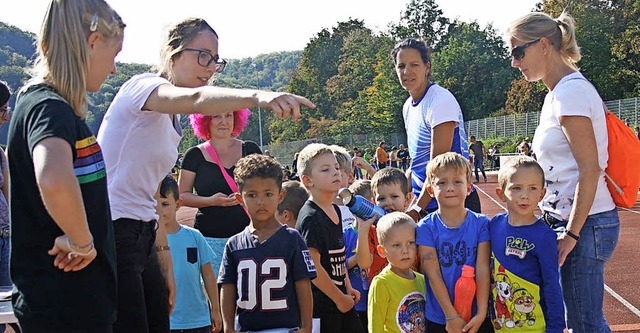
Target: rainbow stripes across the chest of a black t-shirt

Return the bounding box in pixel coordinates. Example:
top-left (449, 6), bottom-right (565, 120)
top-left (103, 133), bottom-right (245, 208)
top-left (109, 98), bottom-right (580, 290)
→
top-left (73, 135), bottom-right (107, 185)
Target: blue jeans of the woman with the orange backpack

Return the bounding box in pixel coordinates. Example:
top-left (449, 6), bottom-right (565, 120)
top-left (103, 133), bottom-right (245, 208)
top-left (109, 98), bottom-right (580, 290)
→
top-left (560, 209), bottom-right (620, 333)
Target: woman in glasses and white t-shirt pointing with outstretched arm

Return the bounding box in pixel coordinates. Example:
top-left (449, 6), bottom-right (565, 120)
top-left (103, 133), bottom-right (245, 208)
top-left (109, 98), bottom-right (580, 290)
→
top-left (98, 19), bottom-right (314, 332)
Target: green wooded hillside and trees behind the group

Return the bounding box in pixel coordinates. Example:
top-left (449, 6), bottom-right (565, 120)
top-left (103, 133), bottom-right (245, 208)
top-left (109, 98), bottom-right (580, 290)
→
top-left (0, 0), bottom-right (640, 144)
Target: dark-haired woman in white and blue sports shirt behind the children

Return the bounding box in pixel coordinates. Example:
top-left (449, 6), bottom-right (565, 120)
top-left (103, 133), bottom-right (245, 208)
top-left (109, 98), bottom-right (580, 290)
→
top-left (391, 39), bottom-right (480, 221)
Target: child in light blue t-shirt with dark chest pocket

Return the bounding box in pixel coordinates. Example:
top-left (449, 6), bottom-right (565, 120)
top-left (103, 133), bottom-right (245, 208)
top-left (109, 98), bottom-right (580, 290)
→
top-left (157, 176), bottom-right (222, 332)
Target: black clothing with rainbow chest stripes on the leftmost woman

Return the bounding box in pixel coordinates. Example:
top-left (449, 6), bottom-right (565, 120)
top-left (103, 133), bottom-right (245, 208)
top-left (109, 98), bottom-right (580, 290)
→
top-left (8, 84), bottom-right (116, 329)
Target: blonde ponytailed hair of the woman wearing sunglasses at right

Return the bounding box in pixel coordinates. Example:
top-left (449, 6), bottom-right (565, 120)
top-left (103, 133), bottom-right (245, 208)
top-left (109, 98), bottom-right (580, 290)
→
top-left (507, 11), bottom-right (582, 70)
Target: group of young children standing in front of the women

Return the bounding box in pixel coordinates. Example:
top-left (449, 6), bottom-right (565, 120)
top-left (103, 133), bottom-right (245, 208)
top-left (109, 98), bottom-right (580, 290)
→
top-left (158, 144), bottom-right (565, 333)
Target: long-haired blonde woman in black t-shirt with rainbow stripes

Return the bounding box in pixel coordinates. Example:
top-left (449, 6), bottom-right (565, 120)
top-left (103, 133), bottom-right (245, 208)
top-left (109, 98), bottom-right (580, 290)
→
top-left (8, 0), bottom-right (125, 332)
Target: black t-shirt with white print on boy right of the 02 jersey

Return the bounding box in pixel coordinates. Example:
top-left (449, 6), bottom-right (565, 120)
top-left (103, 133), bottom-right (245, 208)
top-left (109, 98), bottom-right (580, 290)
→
top-left (296, 200), bottom-right (347, 318)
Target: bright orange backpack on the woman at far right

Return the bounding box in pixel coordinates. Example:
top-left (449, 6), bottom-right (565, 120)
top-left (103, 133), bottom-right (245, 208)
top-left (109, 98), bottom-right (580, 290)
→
top-left (605, 107), bottom-right (640, 208)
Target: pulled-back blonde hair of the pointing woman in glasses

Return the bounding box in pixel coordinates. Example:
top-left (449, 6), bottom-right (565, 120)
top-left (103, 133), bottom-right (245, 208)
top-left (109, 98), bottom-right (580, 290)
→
top-left (156, 18), bottom-right (218, 83)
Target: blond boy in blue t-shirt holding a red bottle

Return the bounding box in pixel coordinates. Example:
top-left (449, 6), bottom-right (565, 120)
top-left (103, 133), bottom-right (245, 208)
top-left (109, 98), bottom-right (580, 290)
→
top-left (416, 152), bottom-right (493, 333)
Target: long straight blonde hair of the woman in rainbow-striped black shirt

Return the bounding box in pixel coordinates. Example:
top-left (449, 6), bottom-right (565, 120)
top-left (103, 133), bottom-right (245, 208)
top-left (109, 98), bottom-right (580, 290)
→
top-left (27, 0), bottom-right (125, 118)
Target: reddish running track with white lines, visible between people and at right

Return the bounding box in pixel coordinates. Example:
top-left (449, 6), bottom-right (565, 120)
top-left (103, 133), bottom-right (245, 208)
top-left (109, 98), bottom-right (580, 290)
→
top-left (178, 172), bottom-right (640, 333)
